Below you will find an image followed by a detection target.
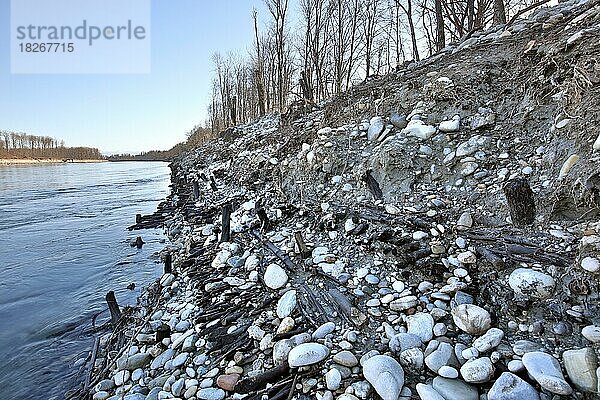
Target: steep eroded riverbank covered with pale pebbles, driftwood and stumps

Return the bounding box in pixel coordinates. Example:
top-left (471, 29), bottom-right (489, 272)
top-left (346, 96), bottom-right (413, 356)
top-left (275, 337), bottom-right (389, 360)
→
top-left (84, 1), bottom-right (600, 400)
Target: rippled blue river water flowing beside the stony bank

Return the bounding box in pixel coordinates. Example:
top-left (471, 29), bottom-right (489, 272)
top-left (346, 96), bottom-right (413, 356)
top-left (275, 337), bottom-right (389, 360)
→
top-left (0, 162), bottom-right (169, 400)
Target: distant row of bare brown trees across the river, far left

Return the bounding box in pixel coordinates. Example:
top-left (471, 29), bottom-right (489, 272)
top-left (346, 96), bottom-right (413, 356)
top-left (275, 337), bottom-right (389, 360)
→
top-left (0, 130), bottom-right (102, 160)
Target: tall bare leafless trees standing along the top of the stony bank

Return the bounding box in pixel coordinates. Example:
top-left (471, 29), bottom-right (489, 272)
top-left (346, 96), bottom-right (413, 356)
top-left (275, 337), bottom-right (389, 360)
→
top-left (205, 0), bottom-right (549, 132)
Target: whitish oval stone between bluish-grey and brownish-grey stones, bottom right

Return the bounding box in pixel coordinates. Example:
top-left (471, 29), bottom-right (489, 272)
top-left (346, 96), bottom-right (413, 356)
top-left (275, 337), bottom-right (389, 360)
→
top-left (523, 351), bottom-right (573, 395)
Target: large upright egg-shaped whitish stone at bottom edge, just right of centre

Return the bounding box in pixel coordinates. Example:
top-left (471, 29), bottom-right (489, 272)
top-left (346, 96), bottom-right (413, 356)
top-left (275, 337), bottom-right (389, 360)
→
top-left (363, 355), bottom-right (404, 400)
